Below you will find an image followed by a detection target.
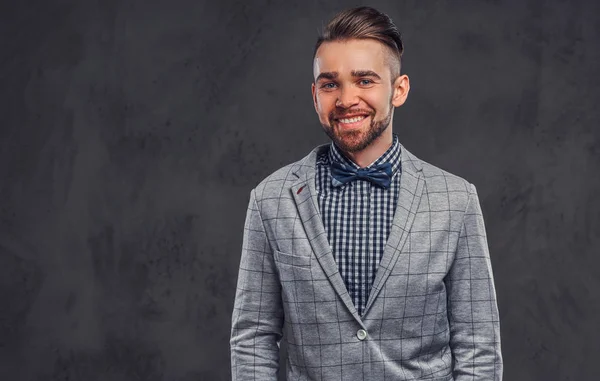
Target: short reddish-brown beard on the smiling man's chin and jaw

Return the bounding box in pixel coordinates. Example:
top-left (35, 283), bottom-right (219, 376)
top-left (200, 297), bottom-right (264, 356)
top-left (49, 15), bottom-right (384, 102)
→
top-left (321, 102), bottom-right (394, 153)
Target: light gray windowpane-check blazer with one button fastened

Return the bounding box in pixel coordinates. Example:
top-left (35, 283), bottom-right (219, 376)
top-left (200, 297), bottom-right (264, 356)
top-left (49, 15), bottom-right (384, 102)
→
top-left (230, 144), bottom-right (502, 381)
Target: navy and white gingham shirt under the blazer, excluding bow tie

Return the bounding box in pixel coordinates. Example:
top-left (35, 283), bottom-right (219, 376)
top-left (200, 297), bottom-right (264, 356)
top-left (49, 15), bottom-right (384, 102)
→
top-left (315, 134), bottom-right (402, 316)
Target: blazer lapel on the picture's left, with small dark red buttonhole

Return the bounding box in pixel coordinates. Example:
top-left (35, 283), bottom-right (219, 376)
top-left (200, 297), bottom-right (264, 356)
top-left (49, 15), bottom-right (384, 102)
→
top-left (290, 144), bottom-right (363, 325)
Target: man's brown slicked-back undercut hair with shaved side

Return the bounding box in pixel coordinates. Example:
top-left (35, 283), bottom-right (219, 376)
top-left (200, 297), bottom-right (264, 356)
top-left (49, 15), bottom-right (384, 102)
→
top-left (313, 7), bottom-right (404, 83)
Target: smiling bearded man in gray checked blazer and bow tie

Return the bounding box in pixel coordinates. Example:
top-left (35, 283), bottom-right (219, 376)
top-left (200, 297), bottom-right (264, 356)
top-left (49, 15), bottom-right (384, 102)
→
top-left (231, 7), bottom-right (502, 381)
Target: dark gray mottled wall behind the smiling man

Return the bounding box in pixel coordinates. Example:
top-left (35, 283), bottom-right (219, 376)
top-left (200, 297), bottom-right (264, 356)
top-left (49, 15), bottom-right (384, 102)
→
top-left (0, 0), bottom-right (600, 381)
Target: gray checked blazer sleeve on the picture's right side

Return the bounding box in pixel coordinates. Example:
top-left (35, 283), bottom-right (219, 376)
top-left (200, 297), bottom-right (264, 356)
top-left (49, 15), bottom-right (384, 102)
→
top-left (445, 184), bottom-right (503, 381)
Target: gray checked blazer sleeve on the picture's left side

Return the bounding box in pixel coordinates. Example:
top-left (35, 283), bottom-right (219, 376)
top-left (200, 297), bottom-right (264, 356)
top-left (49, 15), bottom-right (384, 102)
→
top-left (230, 189), bottom-right (283, 381)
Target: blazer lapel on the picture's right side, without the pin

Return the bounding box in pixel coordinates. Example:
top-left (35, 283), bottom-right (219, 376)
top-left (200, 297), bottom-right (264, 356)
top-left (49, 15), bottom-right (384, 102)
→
top-left (364, 145), bottom-right (424, 314)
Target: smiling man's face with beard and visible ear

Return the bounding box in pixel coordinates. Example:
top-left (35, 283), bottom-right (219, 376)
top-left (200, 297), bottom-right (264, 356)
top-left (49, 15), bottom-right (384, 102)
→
top-left (312, 39), bottom-right (408, 152)
